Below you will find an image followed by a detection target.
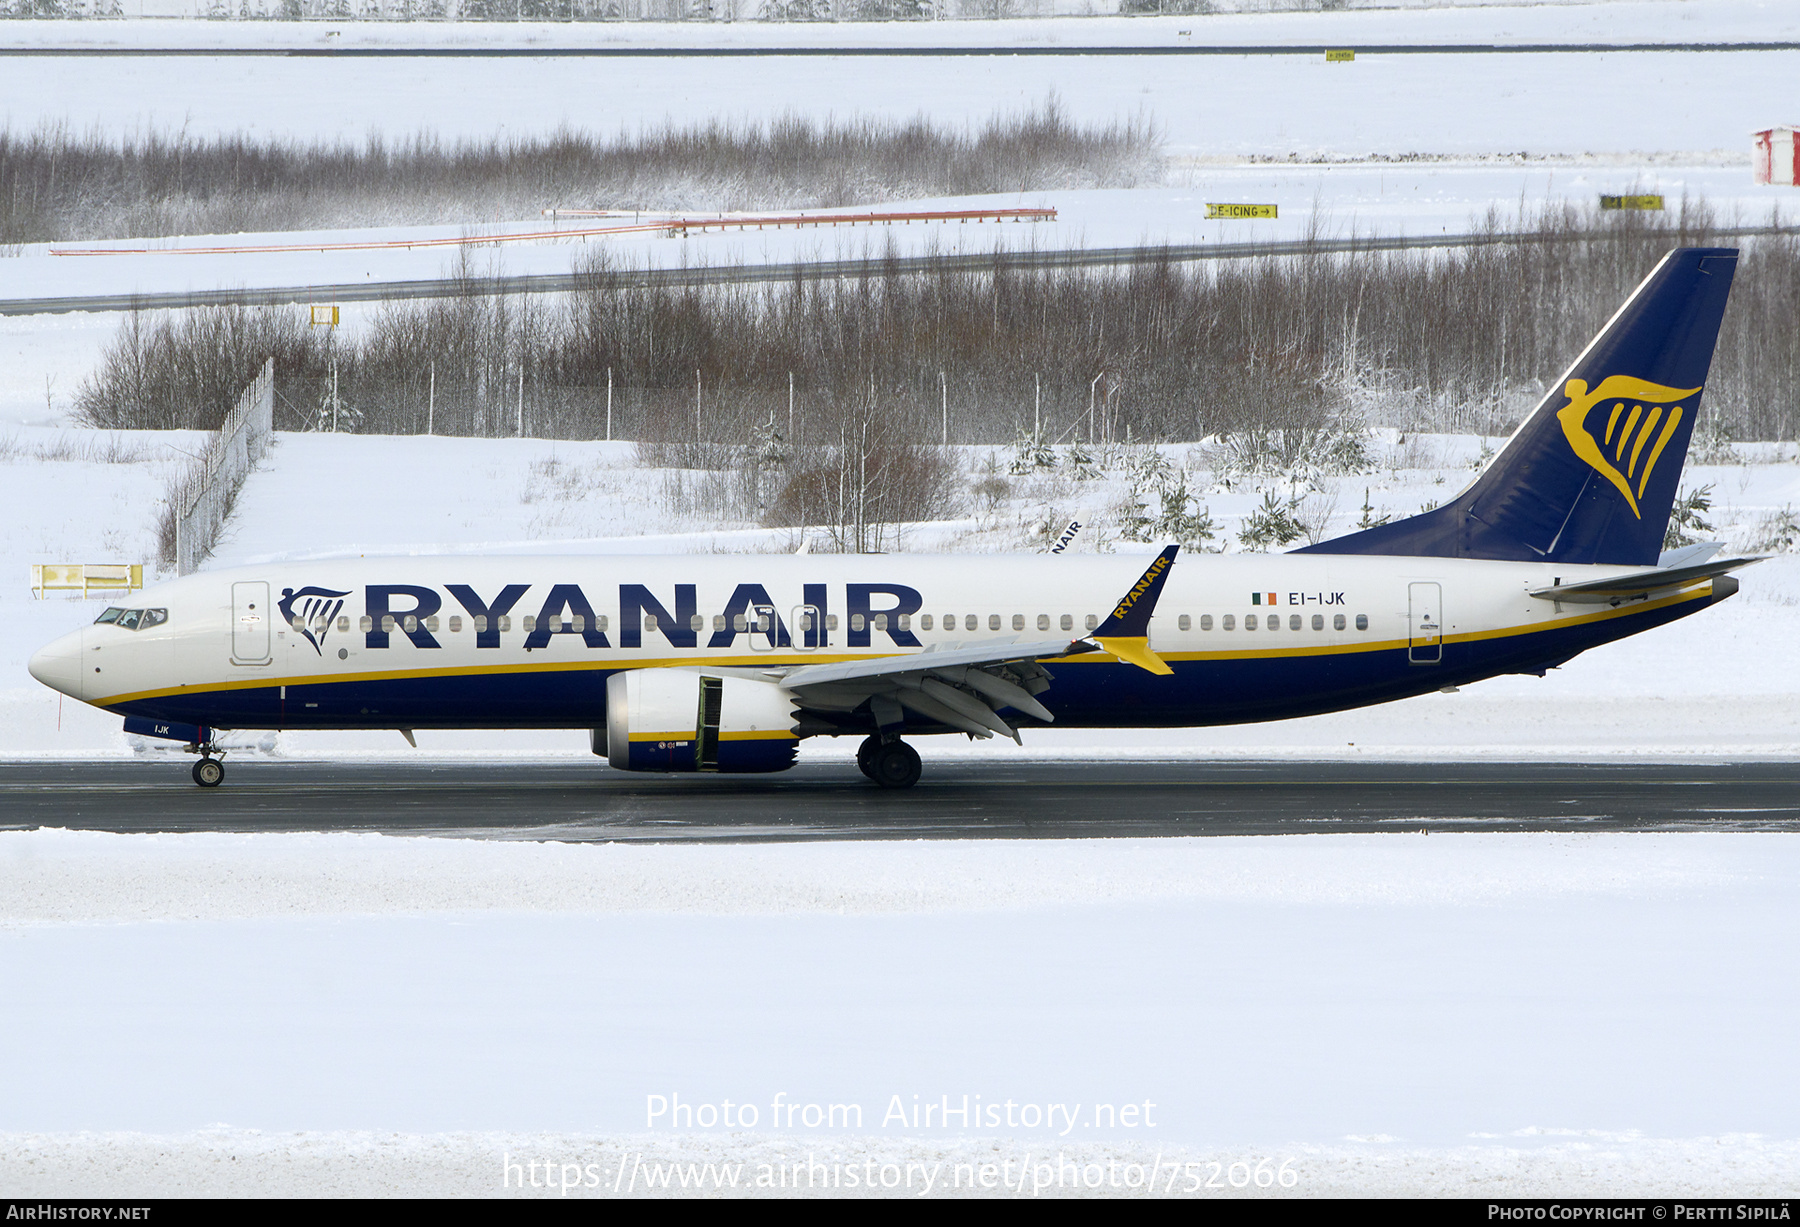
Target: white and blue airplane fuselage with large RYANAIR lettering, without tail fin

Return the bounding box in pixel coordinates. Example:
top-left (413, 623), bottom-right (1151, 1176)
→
top-left (32, 554), bottom-right (1735, 736)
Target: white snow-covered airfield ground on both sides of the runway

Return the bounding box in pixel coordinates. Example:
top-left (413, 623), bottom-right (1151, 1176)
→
top-left (0, 0), bottom-right (1800, 1196)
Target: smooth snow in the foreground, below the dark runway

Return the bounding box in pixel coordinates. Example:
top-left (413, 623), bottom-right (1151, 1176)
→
top-left (0, 831), bottom-right (1800, 1196)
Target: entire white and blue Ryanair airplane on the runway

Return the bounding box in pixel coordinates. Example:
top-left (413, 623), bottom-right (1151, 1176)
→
top-left (31, 248), bottom-right (1753, 788)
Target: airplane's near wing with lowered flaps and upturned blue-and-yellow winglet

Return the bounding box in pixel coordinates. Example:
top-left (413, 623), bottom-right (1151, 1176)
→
top-left (781, 545), bottom-right (1181, 741)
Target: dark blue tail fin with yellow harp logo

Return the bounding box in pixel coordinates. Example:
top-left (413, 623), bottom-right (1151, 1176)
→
top-left (1294, 246), bottom-right (1737, 567)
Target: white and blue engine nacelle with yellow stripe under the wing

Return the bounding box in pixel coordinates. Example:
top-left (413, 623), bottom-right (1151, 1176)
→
top-left (607, 669), bottom-right (799, 772)
